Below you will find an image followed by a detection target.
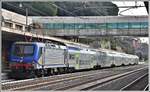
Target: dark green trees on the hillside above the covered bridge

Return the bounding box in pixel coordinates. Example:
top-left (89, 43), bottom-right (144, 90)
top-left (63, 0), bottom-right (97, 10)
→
top-left (2, 2), bottom-right (119, 16)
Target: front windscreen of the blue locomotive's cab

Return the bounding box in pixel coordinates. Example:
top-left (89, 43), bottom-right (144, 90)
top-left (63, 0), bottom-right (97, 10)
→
top-left (13, 44), bottom-right (34, 57)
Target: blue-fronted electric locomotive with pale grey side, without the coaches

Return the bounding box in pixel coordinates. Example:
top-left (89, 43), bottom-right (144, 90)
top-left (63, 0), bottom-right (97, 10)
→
top-left (10, 42), bottom-right (67, 78)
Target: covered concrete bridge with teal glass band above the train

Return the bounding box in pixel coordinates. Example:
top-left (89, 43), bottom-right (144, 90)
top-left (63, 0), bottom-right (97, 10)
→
top-left (31, 16), bottom-right (148, 37)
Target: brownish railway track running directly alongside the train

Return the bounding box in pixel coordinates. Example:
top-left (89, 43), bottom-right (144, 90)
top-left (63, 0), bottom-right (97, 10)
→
top-left (2, 66), bottom-right (148, 90)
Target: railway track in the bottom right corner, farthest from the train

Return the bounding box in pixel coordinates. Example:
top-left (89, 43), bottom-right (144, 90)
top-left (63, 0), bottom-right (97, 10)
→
top-left (82, 69), bottom-right (148, 91)
